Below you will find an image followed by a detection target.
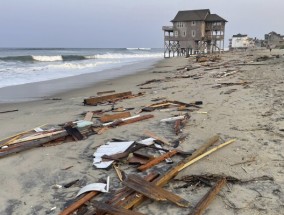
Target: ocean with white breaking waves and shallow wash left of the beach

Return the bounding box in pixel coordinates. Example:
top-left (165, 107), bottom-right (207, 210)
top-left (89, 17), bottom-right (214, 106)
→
top-left (0, 48), bottom-right (163, 102)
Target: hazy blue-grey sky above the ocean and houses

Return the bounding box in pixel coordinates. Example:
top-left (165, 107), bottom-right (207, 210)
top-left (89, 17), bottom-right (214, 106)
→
top-left (0, 0), bottom-right (284, 48)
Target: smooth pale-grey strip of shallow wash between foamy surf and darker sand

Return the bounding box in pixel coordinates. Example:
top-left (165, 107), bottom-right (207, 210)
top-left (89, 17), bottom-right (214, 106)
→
top-left (0, 59), bottom-right (162, 105)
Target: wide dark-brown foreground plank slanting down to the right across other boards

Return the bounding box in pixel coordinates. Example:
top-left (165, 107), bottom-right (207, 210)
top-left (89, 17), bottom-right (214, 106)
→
top-left (122, 175), bottom-right (190, 207)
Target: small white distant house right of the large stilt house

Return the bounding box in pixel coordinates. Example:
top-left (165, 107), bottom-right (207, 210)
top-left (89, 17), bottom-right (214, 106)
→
top-left (230, 34), bottom-right (255, 49)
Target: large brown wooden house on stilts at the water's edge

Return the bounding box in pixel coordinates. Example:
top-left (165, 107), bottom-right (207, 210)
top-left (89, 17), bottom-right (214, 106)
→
top-left (162, 9), bottom-right (227, 57)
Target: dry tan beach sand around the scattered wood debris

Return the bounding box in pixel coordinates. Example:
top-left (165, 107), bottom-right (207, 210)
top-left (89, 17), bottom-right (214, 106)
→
top-left (0, 47), bottom-right (284, 215)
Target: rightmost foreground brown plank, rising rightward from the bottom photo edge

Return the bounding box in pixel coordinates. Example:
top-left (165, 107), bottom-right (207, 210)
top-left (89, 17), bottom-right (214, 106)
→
top-left (189, 178), bottom-right (226, 215)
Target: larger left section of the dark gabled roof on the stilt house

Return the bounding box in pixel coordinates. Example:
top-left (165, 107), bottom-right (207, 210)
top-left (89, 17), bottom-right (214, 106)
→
top-left (171, 9), bottom-right (210, 22)
